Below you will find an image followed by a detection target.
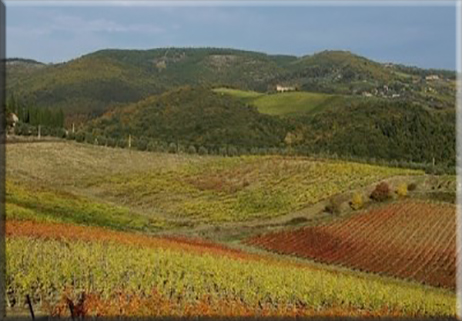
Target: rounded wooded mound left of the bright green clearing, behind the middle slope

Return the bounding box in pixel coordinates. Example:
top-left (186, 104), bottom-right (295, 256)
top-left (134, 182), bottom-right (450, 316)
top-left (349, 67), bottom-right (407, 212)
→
top-left (86, 87), bottom-right (288, 149)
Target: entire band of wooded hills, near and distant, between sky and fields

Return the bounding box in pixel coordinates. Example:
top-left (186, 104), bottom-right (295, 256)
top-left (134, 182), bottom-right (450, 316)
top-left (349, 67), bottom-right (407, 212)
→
top-left (7, 48), bottom-right (455, 172)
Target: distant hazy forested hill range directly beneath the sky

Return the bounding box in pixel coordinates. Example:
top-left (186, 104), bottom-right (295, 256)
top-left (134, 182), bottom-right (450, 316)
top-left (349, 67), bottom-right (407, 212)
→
top-left (7, 48), bottom-right (455, 121)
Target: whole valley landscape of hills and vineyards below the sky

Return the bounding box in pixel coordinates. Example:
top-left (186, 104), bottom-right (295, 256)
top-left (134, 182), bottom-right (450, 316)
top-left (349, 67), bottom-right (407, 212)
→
top-left (5, 48), bottom-right (460, 319)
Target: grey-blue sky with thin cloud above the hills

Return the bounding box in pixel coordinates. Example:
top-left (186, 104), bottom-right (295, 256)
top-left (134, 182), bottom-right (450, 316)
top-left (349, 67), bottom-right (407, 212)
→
top-left (5, 0), bottom-right (456, 70)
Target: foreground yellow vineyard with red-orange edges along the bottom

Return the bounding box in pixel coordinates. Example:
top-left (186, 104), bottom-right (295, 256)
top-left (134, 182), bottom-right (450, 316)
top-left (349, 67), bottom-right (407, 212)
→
top-left (6, 221), bottom-right (456, 317)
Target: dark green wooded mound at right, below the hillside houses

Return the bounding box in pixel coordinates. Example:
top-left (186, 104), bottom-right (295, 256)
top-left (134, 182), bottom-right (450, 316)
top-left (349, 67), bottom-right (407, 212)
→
top-left (300, 101), bottom-right (456, 167)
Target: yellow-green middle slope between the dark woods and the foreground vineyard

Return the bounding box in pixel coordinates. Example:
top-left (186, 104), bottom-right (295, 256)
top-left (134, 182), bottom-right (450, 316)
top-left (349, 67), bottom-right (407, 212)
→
top-left (7, 142), bottom-right (420, 229)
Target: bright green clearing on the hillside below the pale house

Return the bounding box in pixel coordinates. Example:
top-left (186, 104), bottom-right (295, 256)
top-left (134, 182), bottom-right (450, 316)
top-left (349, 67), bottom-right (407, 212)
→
top-left (214, 88), bottom-right (367, 116)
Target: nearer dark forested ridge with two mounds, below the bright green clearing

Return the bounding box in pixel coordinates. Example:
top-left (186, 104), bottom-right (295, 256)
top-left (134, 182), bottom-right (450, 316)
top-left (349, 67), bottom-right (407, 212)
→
top-left (83, 87), bottom-right (455, 170)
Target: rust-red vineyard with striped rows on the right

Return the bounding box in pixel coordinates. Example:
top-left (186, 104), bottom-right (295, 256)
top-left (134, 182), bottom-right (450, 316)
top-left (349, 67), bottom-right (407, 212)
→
top-left (247, 201), bottom-right (456, 289)
